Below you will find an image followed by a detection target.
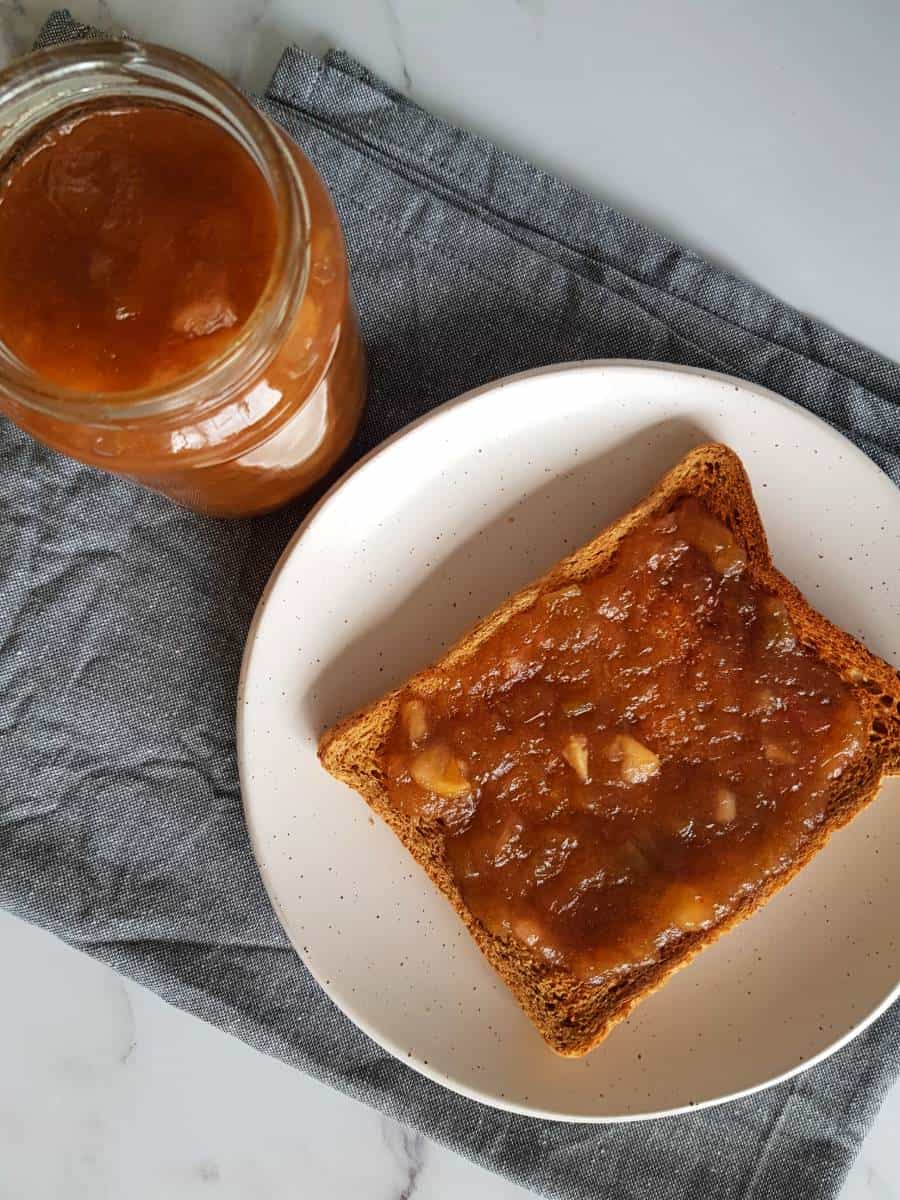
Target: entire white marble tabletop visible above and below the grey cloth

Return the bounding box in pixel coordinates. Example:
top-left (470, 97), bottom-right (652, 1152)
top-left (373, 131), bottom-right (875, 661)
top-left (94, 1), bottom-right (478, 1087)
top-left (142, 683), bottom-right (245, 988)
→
top-left (0, 0), bottom-right (900, 1200)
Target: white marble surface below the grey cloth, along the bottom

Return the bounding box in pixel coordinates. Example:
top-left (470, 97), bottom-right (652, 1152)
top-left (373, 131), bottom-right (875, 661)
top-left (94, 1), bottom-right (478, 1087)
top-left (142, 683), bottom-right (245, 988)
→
top-left (0, 912), bottom-right (900, 1200)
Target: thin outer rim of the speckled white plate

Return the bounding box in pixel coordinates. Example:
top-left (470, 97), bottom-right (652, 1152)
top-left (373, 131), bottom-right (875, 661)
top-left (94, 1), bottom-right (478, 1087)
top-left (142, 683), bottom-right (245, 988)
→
top-left (235, 359), bottom-right (900, 1124)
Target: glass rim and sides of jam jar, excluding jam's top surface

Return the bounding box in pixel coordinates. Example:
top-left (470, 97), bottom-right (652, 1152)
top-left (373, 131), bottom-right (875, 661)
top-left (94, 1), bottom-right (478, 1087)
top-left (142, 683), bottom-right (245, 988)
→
top-left (0, 41), bottom-right (365, 516)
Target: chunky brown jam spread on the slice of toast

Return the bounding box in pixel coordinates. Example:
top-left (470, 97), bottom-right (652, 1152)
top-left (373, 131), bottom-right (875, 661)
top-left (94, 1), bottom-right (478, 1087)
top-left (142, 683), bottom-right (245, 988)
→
top-left (386, 499), bottom-right (864, 983)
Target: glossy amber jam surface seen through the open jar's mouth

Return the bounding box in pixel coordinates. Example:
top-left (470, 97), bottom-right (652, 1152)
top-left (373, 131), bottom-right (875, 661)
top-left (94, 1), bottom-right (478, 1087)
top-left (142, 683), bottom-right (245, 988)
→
top-left (0, 104), bottom-right (277, 392)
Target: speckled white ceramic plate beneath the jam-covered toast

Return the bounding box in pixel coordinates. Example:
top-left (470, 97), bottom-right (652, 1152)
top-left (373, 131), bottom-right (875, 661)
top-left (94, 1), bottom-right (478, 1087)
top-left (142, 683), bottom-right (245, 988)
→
top-left (238, 362), bottom-right (900, 1121)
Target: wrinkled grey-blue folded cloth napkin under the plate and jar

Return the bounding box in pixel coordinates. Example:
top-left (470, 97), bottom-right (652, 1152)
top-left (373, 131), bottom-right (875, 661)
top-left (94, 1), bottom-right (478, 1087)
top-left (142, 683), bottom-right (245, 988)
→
top-left (0, 13), bottom-right (900, 1200)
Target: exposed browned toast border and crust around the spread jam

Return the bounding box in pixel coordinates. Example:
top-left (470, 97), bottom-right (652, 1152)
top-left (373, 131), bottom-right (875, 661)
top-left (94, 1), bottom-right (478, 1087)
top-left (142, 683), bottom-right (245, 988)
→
top-left (319, 444), bottom-right (900, 1056)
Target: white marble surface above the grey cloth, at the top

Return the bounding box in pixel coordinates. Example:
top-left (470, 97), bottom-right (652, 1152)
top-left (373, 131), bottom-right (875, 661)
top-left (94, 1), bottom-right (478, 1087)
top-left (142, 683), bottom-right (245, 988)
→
top-left (0, 0), bottom-right (900, 358)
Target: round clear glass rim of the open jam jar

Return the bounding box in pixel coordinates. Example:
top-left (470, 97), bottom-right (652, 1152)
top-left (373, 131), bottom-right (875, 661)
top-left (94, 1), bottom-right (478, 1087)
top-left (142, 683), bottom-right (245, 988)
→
top-left (0, 38), bottom-right (310, 426)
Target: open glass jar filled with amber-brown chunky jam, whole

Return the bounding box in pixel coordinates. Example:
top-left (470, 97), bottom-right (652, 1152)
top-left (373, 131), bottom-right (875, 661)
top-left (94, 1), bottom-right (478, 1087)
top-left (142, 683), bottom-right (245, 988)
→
top-left (0, 41), bottom-right (365, 516)
